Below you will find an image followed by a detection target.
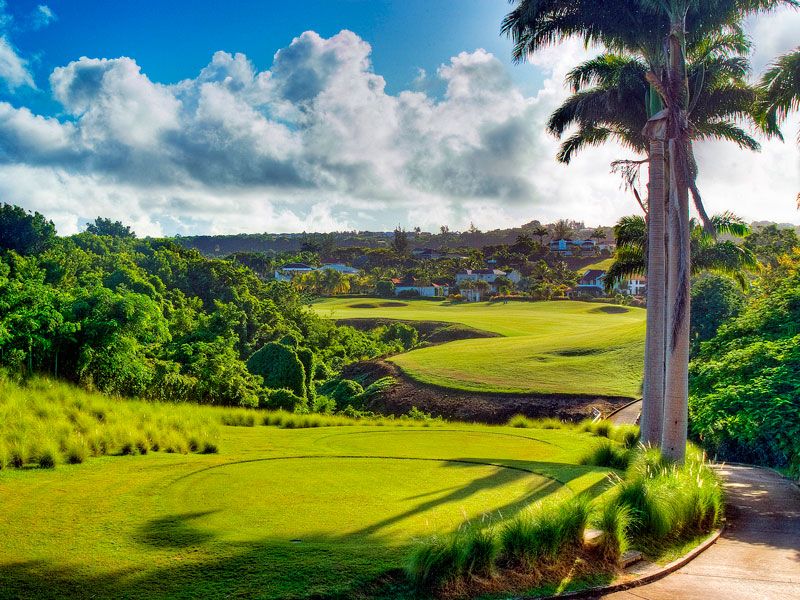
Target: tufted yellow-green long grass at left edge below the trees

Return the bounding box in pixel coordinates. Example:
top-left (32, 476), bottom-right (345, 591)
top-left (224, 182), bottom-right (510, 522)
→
top-left (0, 377), bottom-right (219, 470)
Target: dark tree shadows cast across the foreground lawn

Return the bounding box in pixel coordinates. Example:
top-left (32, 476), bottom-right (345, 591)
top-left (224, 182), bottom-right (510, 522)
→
top-left (0, 458), bottom-right (606, 600)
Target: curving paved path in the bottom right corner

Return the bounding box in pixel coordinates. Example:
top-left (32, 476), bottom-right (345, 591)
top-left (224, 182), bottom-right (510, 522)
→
top-left (604, 465), bottom-right (800, 600)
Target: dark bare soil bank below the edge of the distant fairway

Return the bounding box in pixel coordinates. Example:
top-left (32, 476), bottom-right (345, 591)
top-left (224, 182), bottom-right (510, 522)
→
top-left (342, 360), bottom-right (632, 424)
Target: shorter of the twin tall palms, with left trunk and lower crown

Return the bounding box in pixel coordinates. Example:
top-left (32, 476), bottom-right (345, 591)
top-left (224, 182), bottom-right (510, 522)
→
top-left (548, 36), bottom-right (760, 444)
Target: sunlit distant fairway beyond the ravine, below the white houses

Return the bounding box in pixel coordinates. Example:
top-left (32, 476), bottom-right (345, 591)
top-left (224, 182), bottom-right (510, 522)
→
top-left (313, 298), bottom-right (645, 397)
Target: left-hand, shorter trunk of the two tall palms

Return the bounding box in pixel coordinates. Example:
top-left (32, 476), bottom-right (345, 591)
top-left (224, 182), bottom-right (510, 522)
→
top-left (640, 139), bottom-right (667, 446)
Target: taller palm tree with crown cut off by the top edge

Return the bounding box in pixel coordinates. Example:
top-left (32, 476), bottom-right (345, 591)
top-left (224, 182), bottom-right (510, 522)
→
top-left (502, 0), bottom-right (800, 461)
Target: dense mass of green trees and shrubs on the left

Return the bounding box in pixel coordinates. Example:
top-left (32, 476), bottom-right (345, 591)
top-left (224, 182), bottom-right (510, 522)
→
top-left (0, 205), bottom-right (413, 410)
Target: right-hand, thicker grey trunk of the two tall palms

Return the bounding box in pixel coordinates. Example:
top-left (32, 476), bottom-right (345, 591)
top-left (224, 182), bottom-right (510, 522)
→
top-left (661, 12), bottom-right (691, 463)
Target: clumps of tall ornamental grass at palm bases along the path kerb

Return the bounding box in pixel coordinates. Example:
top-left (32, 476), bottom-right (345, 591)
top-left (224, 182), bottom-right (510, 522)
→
top-left (407, 442), bottom-right (723, 596)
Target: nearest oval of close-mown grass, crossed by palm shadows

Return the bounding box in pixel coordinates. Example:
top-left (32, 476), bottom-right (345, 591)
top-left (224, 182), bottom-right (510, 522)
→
top-left (167, 458), bottom-right (561, 544)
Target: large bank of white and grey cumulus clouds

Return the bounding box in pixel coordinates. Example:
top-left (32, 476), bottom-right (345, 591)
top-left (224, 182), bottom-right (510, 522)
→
top-left (0, 31), bottom-right (800, 234)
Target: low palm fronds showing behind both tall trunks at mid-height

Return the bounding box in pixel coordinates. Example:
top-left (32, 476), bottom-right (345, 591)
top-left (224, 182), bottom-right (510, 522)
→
top-left (605, 212), bottom-right (758, 291)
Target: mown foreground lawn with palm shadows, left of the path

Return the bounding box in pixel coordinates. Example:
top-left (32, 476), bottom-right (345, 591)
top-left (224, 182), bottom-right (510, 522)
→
top-left (0, 418), bottom-right (608, 599)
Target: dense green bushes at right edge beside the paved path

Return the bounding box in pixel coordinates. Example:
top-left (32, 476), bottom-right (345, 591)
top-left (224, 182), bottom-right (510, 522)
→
top-left (689, 251), bottom-right (800, 474)
